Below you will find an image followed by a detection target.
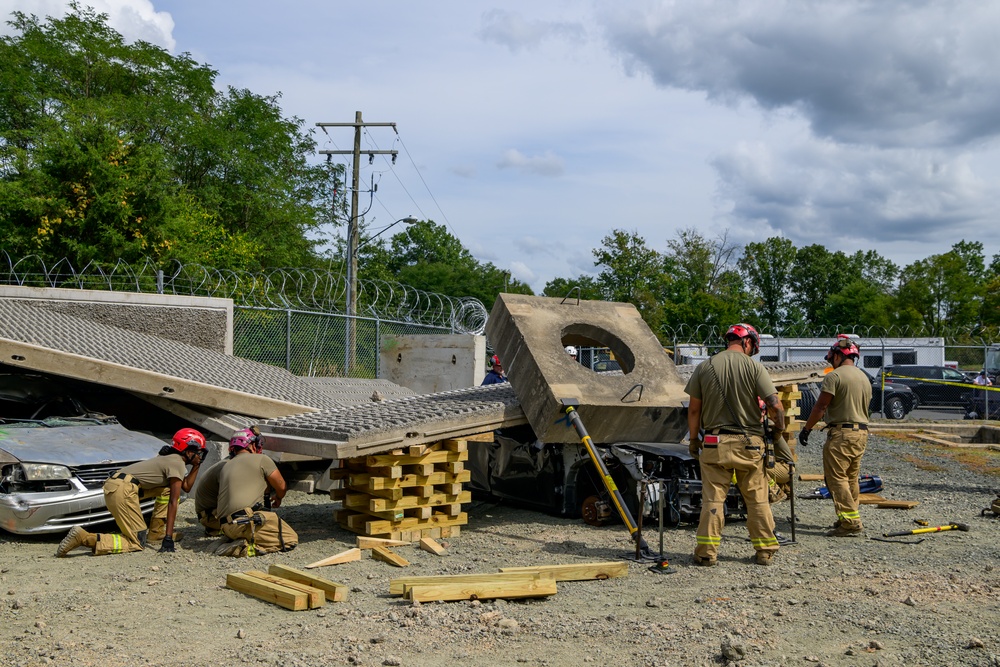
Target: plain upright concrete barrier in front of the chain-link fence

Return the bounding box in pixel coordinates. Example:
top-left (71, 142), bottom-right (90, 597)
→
top-left (379, 334), bottom-right (486, 394)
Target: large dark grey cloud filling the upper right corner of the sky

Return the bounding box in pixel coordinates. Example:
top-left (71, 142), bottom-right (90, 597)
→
top-left (603, 0), bottom-right (1000, 147)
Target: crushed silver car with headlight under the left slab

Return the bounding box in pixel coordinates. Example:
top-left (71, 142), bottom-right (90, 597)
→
top-left (0, 373), bottom-right (164, 534)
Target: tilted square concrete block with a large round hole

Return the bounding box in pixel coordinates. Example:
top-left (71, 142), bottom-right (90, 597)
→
top-left (486, 294), bottom-right (687, 443)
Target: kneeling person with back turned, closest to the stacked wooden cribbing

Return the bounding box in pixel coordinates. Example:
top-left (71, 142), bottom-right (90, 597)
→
top-left (216, 429), bottom-right (299, 558)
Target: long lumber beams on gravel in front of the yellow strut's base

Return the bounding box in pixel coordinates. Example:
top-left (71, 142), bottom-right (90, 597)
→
top-left (389, 561), bottom-right (628, 602)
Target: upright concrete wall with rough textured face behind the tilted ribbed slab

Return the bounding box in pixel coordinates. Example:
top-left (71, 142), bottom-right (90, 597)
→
top-left (0, 285), bottom-right (233, 354)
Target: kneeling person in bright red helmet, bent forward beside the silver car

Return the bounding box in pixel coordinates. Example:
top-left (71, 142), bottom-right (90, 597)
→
top-left (56, 428), bottom-right (208, 556)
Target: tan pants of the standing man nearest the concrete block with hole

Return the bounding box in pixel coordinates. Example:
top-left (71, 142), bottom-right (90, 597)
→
top-left (694, 435), bottom-right (778, 560)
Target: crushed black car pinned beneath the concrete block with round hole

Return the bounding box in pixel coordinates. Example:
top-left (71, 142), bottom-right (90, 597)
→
top-left (468, 426), bottom-right (746, 526)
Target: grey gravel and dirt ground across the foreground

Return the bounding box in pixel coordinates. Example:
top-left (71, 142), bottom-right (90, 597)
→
top-left (0, 434), bottom-right (1000, 667)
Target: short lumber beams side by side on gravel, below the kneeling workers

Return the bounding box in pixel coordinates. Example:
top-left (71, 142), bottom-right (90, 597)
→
top-left (226, 565), bottom-right (347, 611)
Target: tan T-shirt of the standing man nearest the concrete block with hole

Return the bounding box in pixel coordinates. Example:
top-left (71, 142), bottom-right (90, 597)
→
top-left (684, 350), bottom-right (777, 436)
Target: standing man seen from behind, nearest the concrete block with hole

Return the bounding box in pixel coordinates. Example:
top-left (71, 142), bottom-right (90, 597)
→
top-left (684, 324), bottom-right (791, 566)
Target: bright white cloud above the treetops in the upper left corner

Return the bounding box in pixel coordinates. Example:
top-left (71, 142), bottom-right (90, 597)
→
top-left (0, 0), bottom-right (177, 51)
